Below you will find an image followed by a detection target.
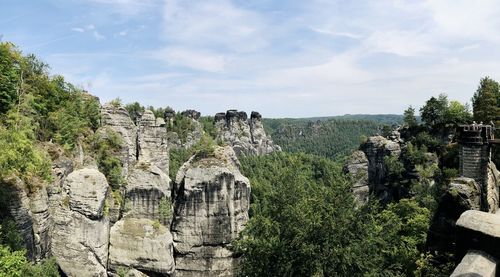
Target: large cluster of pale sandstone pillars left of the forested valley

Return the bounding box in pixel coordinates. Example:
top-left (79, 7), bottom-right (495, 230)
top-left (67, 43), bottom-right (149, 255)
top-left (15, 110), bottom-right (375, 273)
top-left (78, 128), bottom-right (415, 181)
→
top-left (0, 102), bottom-right (254, 276)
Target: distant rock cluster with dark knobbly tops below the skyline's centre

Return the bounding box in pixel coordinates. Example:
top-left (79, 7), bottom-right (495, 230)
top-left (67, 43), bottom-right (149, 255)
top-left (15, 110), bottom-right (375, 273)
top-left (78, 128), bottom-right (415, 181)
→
top-left (215, 110), bottom-right (281, 156)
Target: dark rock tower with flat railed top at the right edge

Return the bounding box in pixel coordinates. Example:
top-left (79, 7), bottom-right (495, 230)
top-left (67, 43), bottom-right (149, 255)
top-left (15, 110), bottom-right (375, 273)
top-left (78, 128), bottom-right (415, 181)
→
top-left (458, 123), bottom-right (498, 211)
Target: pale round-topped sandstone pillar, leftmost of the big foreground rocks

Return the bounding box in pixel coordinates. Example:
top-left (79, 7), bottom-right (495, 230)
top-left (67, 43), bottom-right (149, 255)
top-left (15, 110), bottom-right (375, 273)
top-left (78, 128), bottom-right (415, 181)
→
top-left (51, 169), bottom-right (109, 276)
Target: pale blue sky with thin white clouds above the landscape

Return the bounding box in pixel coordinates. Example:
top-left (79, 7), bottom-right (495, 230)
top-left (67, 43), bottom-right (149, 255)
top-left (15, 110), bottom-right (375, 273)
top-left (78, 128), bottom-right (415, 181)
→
top-left (0, 0), bottom-right (500, 117)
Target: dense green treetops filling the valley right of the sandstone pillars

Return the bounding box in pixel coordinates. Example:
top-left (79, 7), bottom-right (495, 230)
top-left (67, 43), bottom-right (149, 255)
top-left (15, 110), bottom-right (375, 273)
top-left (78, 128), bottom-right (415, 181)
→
top-left (235, 153), bottom-right (436, 276)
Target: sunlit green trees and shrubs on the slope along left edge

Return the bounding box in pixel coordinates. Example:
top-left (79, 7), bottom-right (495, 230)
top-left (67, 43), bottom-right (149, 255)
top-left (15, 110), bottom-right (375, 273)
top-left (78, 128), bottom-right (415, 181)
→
top-left (0, 42), bottom-right (100, 276)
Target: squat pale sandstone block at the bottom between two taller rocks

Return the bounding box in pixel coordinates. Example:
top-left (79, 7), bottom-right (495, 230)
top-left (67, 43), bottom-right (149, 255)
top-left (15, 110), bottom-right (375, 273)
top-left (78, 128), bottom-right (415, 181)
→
top-left (109, 218), bottom-right (175, 275)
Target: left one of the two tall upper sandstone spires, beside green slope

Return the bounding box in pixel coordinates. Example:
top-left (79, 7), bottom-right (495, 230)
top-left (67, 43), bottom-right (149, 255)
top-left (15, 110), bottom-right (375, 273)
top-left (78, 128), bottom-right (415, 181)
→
top-left (98, 104), bottom-right (138, 177)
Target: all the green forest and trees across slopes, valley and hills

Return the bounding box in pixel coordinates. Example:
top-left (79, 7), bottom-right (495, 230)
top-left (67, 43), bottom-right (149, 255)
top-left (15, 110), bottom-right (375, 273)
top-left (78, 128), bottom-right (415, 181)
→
top-left (0, 42), bottom-right (500, 276)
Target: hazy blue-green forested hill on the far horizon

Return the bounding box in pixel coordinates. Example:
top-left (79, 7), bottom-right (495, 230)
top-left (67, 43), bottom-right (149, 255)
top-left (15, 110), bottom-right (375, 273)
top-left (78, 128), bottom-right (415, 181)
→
top-left (263, 114), bottom-right (403, 158)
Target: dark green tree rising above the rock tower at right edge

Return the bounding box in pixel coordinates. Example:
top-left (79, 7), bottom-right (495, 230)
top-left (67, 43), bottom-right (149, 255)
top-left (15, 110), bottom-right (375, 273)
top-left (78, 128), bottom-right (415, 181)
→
top-left (472, 77), bottom-right (500, 123)
